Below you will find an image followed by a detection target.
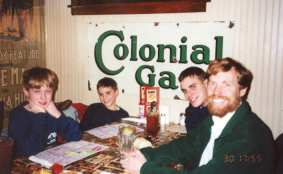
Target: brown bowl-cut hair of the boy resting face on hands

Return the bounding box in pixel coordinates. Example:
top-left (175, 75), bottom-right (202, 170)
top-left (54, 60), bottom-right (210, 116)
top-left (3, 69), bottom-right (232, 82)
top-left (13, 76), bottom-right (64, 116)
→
top-left (23, 67), bottom-right (59, 92)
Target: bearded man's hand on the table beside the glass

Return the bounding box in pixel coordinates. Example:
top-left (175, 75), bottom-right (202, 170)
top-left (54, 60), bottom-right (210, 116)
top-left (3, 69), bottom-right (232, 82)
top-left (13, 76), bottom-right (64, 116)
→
top-left (121, 150), bottom-right (146, 174)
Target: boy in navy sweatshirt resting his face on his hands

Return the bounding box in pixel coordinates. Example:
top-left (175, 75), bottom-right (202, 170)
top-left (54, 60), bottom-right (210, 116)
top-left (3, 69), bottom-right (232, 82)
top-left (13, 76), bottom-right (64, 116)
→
top-left (8, 67), bottom-right (80, 156)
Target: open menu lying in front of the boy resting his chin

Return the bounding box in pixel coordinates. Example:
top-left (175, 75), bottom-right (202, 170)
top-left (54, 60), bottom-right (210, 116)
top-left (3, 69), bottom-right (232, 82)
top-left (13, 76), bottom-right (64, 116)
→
top-left (29, 140), bottom-right (108, 168)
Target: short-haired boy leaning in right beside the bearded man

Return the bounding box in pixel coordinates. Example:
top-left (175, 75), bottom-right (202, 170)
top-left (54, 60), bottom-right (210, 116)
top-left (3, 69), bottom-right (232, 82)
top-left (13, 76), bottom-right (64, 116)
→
top-left (179, 66), bottom-right (209, 132)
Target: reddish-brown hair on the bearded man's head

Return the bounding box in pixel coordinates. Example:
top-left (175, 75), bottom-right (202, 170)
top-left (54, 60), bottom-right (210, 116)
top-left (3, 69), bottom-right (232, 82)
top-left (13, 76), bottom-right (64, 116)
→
top-left (207, 57), bottom-right (253, 100)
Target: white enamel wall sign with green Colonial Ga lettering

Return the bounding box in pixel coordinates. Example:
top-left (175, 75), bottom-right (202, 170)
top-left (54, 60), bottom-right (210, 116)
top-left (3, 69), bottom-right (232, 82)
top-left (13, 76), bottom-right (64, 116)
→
top-left (88, 19), bottom-right (235, 99)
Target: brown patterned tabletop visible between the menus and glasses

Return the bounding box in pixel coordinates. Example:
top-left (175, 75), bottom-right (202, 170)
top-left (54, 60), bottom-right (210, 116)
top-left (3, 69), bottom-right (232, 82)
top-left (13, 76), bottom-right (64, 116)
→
top-left (11, 122), bottom-right (184, 174)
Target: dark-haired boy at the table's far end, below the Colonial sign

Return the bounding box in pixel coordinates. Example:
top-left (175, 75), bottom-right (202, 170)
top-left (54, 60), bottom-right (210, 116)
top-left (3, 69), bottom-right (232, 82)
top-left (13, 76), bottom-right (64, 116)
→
top-left (81, 77), bottom-right (129, 131)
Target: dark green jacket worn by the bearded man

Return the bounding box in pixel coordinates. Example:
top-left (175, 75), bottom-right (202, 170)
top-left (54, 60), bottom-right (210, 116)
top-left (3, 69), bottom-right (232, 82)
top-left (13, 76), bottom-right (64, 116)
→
top-left (140, 101), bottom-right (274, 174)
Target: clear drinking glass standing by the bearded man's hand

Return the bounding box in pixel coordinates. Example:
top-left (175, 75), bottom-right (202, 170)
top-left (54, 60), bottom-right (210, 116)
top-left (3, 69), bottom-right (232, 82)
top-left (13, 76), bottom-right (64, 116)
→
top-left (118, 126), bottom-right (136, 153)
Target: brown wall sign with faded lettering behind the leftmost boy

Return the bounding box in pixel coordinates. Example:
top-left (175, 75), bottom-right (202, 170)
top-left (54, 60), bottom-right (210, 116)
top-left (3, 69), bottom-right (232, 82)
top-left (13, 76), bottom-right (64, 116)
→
top-left (0, 0), bottom-right (45, 128)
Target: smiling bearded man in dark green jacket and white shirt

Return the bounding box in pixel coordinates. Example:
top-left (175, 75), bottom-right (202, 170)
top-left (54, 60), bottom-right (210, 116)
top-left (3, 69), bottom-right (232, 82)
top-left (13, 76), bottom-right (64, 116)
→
top-left (121, 58), bottom-right (274, 174)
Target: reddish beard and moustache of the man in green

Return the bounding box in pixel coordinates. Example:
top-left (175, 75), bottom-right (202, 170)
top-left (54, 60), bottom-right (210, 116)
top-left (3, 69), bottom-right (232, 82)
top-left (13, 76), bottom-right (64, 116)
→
top-left (207, 95), bottom-right (241, 117)
